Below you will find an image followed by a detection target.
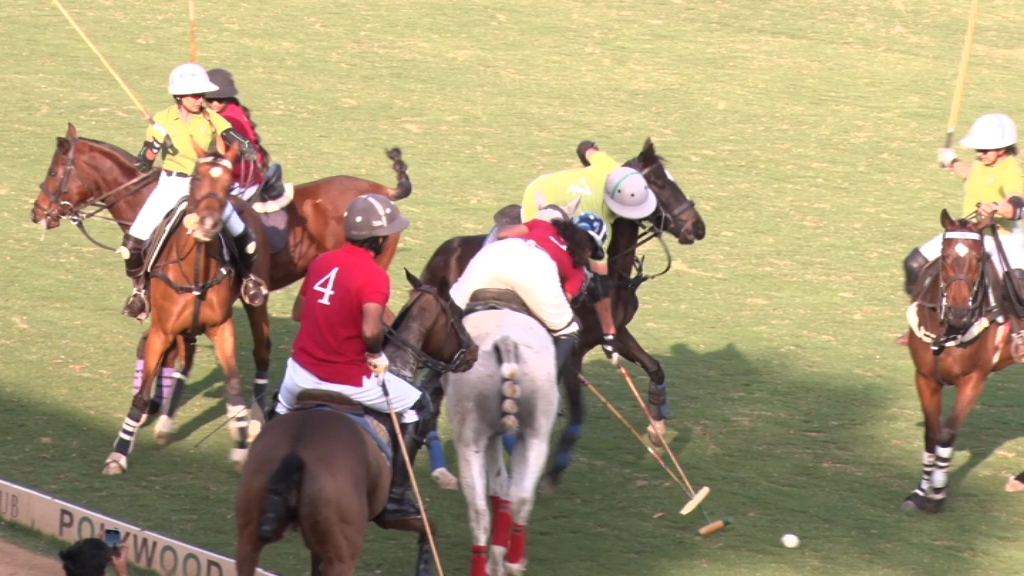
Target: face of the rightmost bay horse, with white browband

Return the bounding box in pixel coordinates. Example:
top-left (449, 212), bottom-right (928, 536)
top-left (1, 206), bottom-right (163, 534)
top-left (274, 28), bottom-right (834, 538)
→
top-left (939, 210), bottom-right (985, 330)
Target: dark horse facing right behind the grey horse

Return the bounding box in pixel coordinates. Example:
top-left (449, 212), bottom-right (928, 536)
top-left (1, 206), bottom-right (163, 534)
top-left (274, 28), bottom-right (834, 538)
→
top-left (422, 138), bottom-right (706, 487)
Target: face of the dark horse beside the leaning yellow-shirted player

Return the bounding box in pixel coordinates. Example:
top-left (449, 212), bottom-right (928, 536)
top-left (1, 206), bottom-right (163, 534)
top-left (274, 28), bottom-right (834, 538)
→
top-left (627, 138), bottom-right (706, 244)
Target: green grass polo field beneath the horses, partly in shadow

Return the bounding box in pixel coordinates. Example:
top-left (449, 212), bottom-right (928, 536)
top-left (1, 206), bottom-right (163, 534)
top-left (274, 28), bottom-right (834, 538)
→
top-left (0, 0), bottom-right (1024, 576)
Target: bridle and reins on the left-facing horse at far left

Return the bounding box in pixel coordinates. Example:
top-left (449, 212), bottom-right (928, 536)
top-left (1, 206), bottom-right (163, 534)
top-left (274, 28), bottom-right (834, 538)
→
top-left (33, 136), bottom-right (160, 252)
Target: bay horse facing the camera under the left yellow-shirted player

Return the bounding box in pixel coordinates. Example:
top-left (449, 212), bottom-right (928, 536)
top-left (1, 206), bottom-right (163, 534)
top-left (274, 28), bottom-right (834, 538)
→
top-left (103, 145), bottom-right (270, 475)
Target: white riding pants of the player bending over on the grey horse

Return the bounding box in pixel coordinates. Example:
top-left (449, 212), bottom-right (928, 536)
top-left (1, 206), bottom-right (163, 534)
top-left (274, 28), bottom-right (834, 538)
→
top-left (451, 238), bottom-right (580, 336)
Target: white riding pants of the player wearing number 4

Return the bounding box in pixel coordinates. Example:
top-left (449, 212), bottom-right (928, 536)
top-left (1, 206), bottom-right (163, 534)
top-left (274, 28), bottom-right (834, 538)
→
top-left (276, 358), bottom-right (423, 424)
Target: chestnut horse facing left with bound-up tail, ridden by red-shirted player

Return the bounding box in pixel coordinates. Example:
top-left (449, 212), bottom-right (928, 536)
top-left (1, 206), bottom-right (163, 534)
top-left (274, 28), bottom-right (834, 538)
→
top-left (31, 124), bottom-right (413, 442)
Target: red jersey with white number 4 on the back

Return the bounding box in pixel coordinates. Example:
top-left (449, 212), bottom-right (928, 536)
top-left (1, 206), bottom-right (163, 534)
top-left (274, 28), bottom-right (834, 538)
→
top-left (292, 239), bottom-right (391, 386)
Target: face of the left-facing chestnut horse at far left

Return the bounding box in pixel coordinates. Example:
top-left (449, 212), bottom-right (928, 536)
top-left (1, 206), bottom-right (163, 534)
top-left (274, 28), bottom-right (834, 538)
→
top-left (32, 124), bottom-right (92, 230)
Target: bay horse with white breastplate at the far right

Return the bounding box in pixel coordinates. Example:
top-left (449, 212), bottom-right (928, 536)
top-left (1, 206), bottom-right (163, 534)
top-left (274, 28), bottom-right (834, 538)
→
top-left (902, 210), bottom-right (1024, 513)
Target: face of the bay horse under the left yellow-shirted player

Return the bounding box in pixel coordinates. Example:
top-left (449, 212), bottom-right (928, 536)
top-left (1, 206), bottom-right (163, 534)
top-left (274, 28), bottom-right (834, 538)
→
top-left (184, 146), bottom-right (238, 242)
